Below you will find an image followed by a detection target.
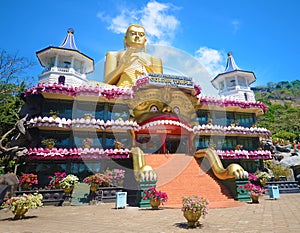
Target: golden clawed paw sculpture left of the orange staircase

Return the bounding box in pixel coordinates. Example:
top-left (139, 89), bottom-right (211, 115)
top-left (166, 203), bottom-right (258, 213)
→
top-left (131, 147), bottom-right (157, 181)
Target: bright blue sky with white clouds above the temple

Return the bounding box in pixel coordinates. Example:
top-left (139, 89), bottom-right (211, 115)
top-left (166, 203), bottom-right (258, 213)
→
top-left (0, 0), bottom-right (300, 86)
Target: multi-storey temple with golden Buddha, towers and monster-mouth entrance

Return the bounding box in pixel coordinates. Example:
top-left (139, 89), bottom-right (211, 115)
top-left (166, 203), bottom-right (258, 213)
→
top-left (17, 25), bottom-right (272, 207)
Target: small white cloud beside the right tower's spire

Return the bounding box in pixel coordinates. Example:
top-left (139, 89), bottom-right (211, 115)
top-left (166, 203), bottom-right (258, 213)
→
top-left (195, 47), bottom-right (226, 78)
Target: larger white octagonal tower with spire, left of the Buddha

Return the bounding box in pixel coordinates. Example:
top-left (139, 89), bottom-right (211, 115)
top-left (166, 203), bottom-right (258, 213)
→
top-left (36, 28), bottom-right (94, 87)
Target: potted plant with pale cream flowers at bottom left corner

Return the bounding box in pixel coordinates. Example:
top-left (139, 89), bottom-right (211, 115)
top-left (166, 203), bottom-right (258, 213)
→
top-left (1, 193), bottom-right (43, 219)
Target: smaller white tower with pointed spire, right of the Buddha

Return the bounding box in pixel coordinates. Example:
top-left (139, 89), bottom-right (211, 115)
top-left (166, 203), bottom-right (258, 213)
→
top-left (211, 52), bottom-right (256, 101)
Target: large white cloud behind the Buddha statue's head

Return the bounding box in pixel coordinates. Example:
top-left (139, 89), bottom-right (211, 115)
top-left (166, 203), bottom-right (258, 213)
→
top-left (97, 1), bottom-right (180, 45)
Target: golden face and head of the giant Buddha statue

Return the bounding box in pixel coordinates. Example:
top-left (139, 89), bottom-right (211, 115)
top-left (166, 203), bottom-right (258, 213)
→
top-left (125, 25), bottom-right (147, 49)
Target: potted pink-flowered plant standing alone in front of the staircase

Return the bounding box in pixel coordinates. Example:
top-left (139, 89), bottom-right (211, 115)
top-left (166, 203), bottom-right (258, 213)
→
top-left (181, 196), bottom-right (209, 227)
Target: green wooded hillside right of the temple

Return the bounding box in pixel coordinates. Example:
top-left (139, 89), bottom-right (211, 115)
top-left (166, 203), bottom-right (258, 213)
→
top-left (252, 80), bottom-right (300, 142)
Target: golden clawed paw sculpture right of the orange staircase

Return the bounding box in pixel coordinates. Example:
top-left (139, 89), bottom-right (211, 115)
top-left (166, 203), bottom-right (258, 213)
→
top-left (194, 148), bottom-right (248, 180)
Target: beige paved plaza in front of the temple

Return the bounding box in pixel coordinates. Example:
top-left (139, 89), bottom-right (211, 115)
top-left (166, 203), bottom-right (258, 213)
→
top-left (0, 194), bottom-right (300, 233)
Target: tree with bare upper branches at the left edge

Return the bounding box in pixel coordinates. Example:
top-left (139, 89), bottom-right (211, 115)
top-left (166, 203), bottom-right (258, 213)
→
top-left (0, 50), bottom-right (35, 173)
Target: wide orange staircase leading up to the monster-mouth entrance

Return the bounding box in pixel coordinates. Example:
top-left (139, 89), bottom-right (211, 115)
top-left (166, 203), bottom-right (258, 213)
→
top-left (145, 154), bottom-right (245, 208)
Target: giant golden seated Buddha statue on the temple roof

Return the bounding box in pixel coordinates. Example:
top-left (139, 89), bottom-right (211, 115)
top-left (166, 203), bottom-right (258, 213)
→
top-left (104, 24), bottom-right (162, 87)
